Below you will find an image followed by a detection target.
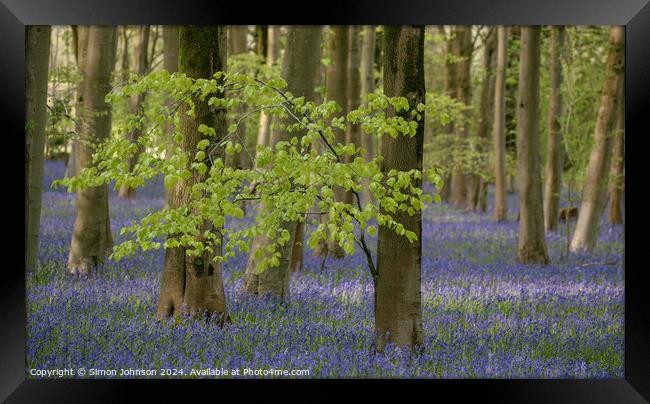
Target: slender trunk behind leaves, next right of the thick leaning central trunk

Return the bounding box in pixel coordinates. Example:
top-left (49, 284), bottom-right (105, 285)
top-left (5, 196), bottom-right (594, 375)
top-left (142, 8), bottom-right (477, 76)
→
top-left (314, 25), bottom-right (352, 258)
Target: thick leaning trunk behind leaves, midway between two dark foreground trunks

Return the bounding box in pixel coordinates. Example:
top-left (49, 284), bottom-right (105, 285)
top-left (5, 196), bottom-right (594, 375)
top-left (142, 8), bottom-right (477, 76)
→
top-left (244, 25), bottom-right (322, 300)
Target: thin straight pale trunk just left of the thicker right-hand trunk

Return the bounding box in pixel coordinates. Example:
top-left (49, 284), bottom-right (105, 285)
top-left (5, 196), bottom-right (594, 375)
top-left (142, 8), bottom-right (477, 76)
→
top-left (492, 26), bottom-right (508, 222)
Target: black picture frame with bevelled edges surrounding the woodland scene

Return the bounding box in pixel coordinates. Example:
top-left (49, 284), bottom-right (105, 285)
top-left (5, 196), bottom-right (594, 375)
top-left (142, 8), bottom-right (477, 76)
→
top-left (0, 0), bottom-right (650, 403)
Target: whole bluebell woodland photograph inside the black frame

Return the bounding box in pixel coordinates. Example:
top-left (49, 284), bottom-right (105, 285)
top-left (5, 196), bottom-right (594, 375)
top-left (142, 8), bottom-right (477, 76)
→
top-left (21, 25), bottom-right (632, 379)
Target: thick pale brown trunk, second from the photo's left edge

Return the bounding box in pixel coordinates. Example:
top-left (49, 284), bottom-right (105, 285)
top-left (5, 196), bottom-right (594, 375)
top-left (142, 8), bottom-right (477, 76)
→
top-left (68, 26), bottom-right (117, 274)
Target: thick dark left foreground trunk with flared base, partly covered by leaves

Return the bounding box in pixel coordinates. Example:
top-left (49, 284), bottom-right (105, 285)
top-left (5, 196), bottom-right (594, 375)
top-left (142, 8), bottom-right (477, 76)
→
top-left (156, 25), bottom-right (229, 324)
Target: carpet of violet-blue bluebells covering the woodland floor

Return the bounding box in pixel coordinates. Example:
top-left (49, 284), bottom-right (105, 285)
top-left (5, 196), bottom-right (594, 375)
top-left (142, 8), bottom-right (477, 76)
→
top-left (26, 161), bottom-right (624, 378)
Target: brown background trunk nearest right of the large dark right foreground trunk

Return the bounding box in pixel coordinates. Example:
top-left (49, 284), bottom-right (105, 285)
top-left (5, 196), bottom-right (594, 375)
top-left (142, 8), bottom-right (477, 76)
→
top-left (450, 25), bottom-right (473, 208)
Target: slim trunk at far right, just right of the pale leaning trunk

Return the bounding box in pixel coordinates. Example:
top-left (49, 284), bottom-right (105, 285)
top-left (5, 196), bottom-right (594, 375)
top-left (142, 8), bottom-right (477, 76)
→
top-left (607, 90), bottom-right (625, 225)
